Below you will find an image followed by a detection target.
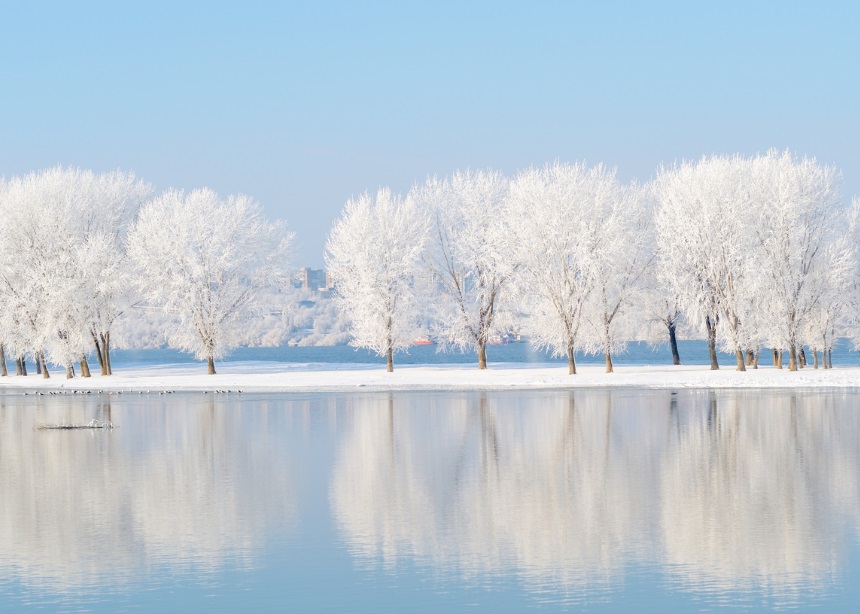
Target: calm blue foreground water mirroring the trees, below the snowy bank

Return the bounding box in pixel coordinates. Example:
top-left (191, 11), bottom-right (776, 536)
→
top-left (0, 389), bottom-right (860, 612)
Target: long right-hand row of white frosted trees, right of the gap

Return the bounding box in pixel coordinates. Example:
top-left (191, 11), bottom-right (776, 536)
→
top-left (326, 151), bottom-right (860, 374)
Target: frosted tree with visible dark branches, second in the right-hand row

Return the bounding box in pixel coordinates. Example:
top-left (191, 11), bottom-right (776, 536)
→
top-left (409, 170), bottom-right (514, 369)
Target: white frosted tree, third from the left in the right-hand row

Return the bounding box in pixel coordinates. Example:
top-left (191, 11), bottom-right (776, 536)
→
top-left (509, 162), bottom-right (619, 375)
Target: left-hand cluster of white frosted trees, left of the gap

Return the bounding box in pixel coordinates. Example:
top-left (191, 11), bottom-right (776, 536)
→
top-left (0, 168), bottom-right (292, 377)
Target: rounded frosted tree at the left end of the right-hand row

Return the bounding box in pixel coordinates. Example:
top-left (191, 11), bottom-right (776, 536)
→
top-left (326, 188), bottom-right (429, 371)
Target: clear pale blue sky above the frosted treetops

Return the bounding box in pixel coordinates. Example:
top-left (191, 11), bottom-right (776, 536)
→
top-left (0, 0), bottom-right (860, 266)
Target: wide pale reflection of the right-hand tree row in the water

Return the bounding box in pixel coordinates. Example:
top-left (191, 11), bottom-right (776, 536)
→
top-left (330, 390), bottom-right (860, 605)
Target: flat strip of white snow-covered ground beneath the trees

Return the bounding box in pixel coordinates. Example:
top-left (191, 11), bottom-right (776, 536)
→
top-left (0, 362), bottom-right (860, 392)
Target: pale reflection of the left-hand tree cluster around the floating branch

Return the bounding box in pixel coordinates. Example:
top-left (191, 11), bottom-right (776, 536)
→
top-left (0, 395), bottom-right (296, 591)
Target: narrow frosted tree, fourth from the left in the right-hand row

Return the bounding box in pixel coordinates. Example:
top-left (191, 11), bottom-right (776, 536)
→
top-left (585, 185), bottom-right (654, 373)
